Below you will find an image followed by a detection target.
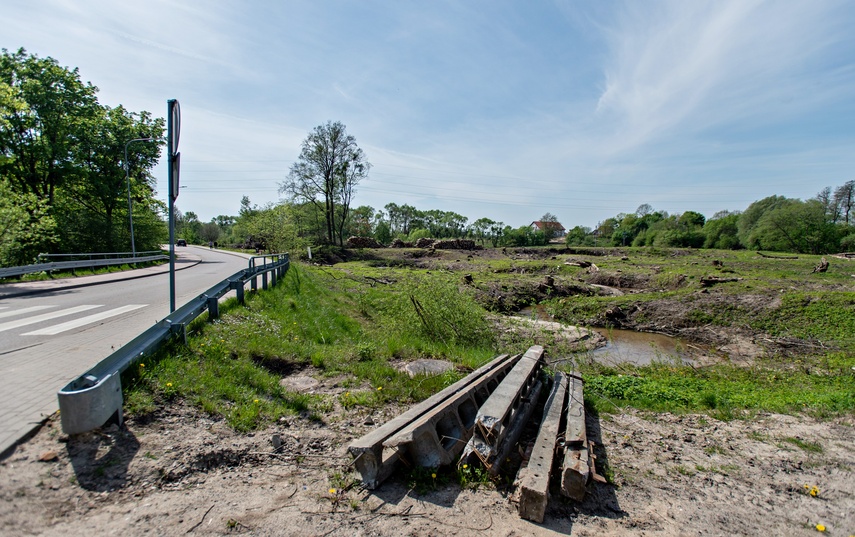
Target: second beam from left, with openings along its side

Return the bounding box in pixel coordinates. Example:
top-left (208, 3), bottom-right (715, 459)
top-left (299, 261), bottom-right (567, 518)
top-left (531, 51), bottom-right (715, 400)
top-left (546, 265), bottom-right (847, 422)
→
top-left (383, 355), bottom-right (519, 468)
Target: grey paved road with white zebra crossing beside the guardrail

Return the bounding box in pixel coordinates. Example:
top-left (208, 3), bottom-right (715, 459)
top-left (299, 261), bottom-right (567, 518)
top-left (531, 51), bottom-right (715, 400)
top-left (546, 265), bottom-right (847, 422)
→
top-left (0, 246), bottom-right (248, 459)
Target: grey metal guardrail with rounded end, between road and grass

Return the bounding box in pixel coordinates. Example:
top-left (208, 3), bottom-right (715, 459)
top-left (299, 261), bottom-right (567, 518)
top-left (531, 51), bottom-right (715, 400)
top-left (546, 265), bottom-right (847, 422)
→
top-left (57, 254), bottom-right (291, 434)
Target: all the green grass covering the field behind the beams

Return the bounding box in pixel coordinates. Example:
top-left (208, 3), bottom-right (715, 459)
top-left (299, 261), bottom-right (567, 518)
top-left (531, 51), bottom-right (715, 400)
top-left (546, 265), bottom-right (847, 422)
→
top-left (123, 248), bottom-right (855, 432)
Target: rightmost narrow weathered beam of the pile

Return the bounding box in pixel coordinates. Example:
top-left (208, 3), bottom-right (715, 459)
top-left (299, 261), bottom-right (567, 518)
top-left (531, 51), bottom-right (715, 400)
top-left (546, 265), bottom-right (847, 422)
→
top-left (561, 375), bottom-right (591, 501)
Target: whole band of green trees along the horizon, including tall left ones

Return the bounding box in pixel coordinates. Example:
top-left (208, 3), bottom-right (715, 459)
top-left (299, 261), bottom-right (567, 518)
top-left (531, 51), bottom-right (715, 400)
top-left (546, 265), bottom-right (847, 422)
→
top-left (5, 49), bottom-right (855, 266)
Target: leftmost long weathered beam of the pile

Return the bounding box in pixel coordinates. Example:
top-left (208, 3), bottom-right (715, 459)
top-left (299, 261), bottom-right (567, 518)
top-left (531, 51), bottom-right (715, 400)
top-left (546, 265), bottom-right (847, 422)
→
top-left (347, 354), bottom-right (520, 489)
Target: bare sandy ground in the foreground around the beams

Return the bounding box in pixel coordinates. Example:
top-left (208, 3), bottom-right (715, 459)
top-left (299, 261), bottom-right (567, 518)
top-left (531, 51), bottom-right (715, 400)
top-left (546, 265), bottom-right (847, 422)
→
top-left (0, 396), bottom-right (855, 536)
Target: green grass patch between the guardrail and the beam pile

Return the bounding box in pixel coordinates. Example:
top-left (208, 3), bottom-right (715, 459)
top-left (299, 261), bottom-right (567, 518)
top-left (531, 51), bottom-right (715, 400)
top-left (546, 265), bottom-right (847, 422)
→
top-left (123, 264), bottom-right (494, 431)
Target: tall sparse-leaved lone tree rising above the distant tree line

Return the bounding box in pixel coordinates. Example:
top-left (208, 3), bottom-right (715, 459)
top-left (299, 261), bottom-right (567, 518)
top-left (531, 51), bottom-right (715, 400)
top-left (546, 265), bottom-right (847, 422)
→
top-left (279, 121), bottom-right (371, 244)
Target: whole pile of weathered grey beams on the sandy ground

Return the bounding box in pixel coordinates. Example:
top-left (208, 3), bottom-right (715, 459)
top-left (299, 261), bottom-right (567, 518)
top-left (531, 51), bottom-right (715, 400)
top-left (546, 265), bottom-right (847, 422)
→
top-left (348, 345), bottom-right (597, 522)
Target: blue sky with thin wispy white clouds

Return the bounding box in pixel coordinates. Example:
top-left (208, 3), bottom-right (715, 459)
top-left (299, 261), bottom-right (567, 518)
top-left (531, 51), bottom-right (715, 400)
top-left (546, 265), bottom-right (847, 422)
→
top-left (5, 0), bottom-right (855, 229)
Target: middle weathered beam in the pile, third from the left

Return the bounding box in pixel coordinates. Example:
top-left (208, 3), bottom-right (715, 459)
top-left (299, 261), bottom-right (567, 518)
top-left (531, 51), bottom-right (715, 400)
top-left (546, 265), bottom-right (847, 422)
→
top-left (461, 345), bottom-right (543, 468)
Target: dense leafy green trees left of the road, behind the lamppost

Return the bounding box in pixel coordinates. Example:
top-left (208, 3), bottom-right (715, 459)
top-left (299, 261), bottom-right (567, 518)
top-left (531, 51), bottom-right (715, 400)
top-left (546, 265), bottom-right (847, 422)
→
top-left (0, 48), bottom-right (166, 266)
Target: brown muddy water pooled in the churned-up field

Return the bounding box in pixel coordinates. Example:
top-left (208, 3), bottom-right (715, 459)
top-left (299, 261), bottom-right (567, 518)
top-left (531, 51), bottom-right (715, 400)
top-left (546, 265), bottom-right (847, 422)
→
top-left (517, 305), bottom-right (692, 365)
